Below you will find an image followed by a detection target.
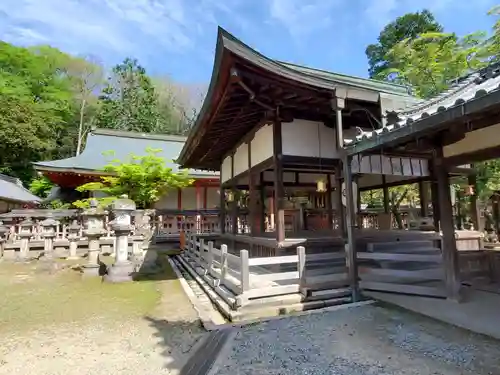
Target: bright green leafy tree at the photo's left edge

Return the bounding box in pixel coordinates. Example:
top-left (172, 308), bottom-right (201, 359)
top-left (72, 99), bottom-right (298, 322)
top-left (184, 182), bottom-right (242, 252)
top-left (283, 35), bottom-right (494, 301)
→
top-left (0, 42), bottom-right (78, 182)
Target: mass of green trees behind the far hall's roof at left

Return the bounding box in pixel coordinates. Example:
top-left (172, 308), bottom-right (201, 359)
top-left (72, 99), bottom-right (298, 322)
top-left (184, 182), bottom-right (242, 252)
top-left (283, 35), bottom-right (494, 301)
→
top-left (0, 41), bottom-right (203, 184)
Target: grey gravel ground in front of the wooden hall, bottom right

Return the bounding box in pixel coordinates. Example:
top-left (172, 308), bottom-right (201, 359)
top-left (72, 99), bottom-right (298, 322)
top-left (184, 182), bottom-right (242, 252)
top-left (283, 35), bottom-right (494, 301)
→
top-left (213, 305), bottom-right (500, 375)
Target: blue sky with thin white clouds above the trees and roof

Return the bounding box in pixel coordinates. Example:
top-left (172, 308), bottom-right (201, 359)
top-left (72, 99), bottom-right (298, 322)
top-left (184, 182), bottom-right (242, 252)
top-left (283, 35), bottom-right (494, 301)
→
top-left (0, 0), bottom-right (499, 84)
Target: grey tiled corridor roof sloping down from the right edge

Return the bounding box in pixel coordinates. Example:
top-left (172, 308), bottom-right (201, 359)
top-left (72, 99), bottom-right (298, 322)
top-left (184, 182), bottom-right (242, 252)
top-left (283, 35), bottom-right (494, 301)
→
top-left (348, 64), bottom-right (500, 154)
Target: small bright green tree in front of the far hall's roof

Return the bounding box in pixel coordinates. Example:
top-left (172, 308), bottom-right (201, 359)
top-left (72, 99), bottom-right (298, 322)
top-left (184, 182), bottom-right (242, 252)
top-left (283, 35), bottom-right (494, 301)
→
top-left (74, 149), bottom-right (193, 208)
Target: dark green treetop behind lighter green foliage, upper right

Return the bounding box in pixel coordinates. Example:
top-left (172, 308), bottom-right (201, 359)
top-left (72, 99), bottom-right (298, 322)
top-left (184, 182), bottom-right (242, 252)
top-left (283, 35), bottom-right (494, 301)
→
top-left (365, 9), bottom-right (443, 79)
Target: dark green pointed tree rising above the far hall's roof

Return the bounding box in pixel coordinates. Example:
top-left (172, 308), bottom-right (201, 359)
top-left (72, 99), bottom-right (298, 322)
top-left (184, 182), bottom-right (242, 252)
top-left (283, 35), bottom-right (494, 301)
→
top-left (96, 58), bottom-right (160, 133)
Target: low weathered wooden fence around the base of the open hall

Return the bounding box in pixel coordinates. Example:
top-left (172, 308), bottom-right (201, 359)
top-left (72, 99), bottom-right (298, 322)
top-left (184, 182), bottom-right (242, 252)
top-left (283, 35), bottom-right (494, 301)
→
top-left (184, 234), bottom-right (350, 309)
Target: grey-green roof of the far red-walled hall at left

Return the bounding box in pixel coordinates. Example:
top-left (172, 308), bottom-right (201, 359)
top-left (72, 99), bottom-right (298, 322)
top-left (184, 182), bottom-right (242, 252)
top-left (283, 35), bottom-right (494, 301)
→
top-left (33, 129), bottom-right (218, 178)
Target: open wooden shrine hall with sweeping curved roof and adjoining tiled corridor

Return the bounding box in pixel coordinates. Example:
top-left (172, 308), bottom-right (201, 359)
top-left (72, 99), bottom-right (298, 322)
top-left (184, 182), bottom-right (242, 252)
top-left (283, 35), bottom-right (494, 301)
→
top-left (178, 29), bottom-right (497, 301)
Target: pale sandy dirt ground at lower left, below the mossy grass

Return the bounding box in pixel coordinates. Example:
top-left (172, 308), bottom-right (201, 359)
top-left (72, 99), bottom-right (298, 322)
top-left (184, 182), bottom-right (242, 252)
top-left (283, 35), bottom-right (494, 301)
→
top-left (0, 262), bottom-right (205, 375)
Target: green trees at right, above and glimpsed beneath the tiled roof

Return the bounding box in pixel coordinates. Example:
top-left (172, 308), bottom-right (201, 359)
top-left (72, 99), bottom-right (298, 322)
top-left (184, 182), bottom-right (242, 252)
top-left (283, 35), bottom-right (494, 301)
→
top-left (363, 7), bottom-right (500, 222)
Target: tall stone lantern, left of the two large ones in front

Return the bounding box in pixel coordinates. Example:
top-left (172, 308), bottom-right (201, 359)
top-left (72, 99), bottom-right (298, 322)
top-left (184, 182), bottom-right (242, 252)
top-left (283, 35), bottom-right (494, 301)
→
top-left (82, 199), bottom-right (107, 276)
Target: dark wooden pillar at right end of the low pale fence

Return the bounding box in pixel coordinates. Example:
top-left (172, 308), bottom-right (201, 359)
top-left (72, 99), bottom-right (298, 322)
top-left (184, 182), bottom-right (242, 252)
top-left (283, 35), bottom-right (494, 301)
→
top-left (344, 157), bottom-right (359, 302)
